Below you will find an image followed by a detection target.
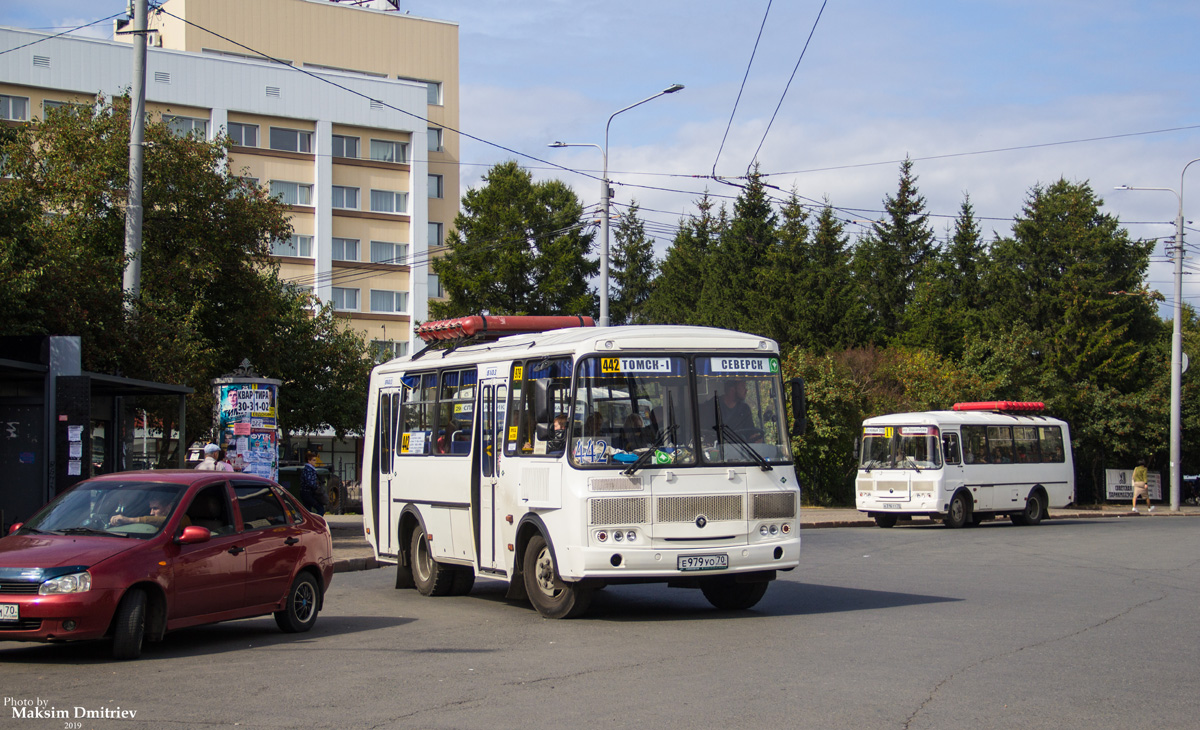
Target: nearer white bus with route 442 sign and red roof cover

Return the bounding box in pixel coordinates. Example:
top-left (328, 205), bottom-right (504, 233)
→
top-left (362, 317), bottom-right (804, 618)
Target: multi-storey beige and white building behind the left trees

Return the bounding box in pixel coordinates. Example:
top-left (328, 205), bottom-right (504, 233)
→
top-left (0, 0), bottom-right (460, 478)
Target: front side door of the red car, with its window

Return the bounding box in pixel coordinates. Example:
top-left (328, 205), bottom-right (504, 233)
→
top-left (169, 481), bottom-right (247, 620)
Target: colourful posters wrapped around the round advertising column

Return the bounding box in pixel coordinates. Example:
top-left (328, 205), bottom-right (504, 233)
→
top-left (217, 383), bottom-right (280, 479)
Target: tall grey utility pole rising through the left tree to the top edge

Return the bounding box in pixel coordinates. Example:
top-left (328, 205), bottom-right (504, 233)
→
top-left (124, 0), bottom-right (146, 311)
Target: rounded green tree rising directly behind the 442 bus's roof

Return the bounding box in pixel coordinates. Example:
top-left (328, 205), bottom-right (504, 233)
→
top-left (430, 161), bottom-right (599, 319)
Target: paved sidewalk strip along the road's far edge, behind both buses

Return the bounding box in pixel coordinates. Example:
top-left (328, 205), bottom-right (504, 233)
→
top-left (325, 504), bottom-right (1200, 573)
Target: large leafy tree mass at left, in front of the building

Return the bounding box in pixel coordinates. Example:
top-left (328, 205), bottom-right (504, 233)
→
top-left (0, 97), bottom-right (370, 457)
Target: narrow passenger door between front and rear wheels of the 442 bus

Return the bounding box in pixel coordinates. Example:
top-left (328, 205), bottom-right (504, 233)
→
top-left (475, 381), bottom-right (508, 570)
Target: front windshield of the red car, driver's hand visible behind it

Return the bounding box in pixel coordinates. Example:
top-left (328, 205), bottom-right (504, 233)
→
top-left (20, 481), bottom-right (185, 538)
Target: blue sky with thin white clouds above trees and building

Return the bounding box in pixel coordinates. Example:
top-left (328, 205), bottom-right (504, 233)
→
top-left (7, 0), bottom-right (1200, 306)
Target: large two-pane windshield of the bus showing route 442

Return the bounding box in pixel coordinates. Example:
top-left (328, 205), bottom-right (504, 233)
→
top-left (569, 355), bottom-right (791, 467)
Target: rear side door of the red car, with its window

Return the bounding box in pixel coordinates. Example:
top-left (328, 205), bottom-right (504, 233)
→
top-left (233, 479), bottom-right (304, 606)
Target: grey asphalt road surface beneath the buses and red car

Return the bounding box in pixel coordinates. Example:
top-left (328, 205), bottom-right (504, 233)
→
top-left (0, 519), bottom-right (1200, 730)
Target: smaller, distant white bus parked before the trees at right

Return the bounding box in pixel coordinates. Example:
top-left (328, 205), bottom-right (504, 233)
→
top-left (854, 401), bottom-right (1075, 527)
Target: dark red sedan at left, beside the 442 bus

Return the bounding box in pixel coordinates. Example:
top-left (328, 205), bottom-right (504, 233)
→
top-left (0, 471), bottom-right (334, 659)
